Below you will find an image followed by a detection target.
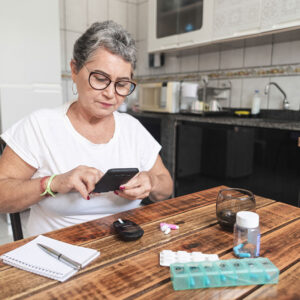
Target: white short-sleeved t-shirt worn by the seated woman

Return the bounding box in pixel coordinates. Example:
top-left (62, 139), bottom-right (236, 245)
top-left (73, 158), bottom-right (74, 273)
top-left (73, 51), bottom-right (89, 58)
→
top-left (1, 103), bottom-right (161, 236)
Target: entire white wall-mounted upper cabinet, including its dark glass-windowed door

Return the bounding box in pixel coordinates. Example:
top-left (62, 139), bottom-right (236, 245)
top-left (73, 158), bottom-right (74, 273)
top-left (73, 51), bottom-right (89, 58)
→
top-left (148, 0), bottom-right (300, 52)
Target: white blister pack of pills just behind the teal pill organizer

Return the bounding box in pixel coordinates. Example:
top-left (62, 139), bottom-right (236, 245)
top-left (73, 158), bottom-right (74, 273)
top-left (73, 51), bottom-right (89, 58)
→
top-left (160, 250), bottom-right (219, 267)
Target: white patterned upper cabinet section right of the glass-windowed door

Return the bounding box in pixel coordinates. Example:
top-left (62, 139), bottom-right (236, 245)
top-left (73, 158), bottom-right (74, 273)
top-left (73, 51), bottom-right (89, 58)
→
top-left (212, 0), bottom-right (300, 41)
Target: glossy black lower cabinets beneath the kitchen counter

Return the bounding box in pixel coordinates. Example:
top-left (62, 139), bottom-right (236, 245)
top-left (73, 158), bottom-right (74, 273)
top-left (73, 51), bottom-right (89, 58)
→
top-left (175, 122), bottom-right (300, 206)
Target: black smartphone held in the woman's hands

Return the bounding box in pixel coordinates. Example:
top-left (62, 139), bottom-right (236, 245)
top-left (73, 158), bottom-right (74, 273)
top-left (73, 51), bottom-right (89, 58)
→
top-left (93, 168), bottom-right (139, 193)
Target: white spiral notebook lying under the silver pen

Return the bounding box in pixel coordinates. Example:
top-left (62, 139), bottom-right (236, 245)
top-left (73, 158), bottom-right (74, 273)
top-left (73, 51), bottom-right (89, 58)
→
top-left (0, 235), bottom-right (100, 281)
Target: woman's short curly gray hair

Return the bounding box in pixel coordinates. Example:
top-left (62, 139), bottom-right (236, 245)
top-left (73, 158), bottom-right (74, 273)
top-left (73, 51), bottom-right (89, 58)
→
top-left (73, 21), bottom-right (136, 71)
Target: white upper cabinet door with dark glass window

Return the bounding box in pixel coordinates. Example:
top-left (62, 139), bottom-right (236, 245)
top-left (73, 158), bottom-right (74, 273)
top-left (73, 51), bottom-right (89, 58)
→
top-left (148, 0), bottom-right (213, 52)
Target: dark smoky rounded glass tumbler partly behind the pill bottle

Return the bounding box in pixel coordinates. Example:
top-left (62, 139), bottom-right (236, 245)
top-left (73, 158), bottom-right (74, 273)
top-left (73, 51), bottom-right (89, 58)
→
top-left (216, 188), bottom-right (255, 231)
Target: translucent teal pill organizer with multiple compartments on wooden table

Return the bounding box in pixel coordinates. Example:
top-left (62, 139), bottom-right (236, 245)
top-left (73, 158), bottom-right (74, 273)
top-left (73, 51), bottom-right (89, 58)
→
top-left (170, 257), bottom-right (279, 290)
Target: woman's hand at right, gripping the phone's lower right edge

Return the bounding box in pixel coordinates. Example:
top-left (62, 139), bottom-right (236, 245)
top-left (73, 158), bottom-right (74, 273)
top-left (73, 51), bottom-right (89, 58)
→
top-left (115, 172), bottom-right (153, 200)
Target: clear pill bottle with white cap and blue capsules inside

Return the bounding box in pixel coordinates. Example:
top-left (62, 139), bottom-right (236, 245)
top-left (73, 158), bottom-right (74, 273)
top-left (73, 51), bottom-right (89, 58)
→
top-left (233, 211), bottom-right (260, 258)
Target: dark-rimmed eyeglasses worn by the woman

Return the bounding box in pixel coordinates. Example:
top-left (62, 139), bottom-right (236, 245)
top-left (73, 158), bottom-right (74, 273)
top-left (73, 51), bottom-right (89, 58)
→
top-left (85, 66), bottom-right (136, 97)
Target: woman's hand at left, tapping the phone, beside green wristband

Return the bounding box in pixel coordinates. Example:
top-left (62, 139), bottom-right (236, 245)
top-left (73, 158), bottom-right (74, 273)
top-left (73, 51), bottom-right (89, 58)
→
top-left (51, 166), bottom-right (103, 200)
